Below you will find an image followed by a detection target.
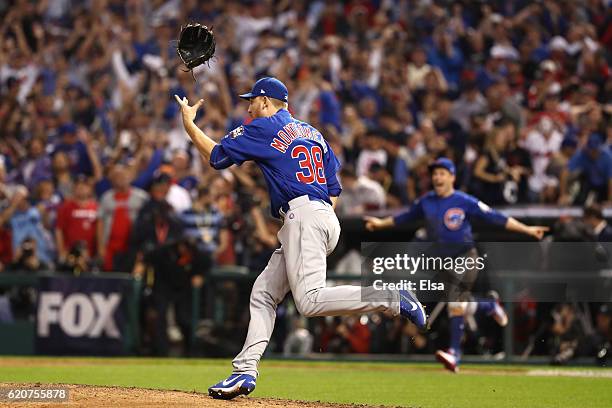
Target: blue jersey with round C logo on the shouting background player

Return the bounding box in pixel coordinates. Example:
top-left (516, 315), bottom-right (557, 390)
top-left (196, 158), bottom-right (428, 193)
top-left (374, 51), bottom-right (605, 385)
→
top-left (393, 191), bottom-right (508, 243)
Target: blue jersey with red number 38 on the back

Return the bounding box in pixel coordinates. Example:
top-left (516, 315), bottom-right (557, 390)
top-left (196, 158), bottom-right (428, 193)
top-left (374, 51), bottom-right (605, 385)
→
top-left (210, 109), bottom-right (342, 217)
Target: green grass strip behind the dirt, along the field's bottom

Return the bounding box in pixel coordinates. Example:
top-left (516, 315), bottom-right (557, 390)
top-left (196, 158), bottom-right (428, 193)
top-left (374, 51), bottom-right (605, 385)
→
top-left (0, 357), bottom-right (612, 408)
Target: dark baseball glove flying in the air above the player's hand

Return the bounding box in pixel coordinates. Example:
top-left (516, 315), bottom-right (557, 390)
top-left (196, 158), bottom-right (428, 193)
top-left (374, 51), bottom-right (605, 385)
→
top-left (176, 23), bottom-right (215, 70)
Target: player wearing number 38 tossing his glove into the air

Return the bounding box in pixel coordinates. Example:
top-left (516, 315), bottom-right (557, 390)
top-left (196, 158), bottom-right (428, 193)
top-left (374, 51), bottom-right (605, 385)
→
top-left (175, 78), bottom-right (425, 399)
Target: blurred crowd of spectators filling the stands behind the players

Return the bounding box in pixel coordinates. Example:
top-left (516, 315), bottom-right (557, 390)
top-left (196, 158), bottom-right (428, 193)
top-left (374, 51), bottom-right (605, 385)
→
top-left (0, 0), bottom-right (612, 360)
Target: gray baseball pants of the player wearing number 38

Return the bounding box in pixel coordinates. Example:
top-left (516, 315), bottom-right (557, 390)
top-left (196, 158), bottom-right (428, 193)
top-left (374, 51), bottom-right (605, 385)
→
top-left (232, 196), bottom-right (399, 377)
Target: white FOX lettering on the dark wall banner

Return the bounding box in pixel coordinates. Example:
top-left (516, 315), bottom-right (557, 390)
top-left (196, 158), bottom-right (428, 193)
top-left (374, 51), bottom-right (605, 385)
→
top-left (37, 292), bottom-right (121, 339)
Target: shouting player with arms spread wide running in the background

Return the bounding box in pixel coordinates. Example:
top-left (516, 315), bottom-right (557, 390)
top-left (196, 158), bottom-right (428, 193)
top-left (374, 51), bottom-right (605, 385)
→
top-left (365, 158), bottom-right (548, 372)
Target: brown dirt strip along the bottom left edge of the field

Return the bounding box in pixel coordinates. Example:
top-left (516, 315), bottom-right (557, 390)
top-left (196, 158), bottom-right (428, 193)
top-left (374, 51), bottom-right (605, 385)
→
top-left (0, 383), bottom-right (378, 408)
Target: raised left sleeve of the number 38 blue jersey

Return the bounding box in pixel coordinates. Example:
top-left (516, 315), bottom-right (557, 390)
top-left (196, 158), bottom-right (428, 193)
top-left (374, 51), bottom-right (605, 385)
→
top-left (221, 123), bottom-right (265, 167)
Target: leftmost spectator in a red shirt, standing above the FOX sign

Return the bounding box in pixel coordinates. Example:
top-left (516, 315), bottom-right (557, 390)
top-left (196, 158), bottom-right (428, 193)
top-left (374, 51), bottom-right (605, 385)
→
top-left (55, 176), bottom-right (98, 260)
